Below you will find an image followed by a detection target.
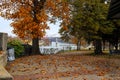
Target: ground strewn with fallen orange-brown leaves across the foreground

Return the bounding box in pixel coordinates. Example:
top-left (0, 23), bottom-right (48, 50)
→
top-left (6, 52), bottom-right (120, 80)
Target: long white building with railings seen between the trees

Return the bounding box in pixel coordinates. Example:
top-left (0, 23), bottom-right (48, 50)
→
top-left (40, 37), bottom-right (77, 54)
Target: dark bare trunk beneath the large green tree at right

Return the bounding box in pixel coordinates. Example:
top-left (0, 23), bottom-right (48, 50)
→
top-left (94, 39), bottom-right (102, 54)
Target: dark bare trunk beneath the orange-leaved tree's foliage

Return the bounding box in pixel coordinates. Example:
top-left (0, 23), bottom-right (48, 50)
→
top-left (32, 38), bottom-right (40, 54)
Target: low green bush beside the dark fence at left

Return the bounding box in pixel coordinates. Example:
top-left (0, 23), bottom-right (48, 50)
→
top-left (7, 39), bottom-right (24, 58)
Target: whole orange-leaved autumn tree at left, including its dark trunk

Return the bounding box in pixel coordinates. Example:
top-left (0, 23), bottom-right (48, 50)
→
top-left (0, 0), bottom-right (69, 54)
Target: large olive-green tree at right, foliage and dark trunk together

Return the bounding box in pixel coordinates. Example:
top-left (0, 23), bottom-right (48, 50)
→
top-left (60, 0), bottom-right (114, 54)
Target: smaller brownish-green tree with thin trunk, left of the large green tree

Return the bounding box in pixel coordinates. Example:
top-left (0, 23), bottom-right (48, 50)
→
top-left (59, 24), bottom-right (83, 50)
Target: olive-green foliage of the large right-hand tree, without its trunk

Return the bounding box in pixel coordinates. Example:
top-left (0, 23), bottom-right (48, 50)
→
top-left (72, 0), bottom-right (113, 38)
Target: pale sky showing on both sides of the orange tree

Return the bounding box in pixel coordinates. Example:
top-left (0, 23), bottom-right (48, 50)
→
top-left (0, 17), bottom-right (60, 37)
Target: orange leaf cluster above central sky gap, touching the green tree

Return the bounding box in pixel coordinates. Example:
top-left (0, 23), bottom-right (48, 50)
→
top-left (46, 0), bottom-right (70, 25)
